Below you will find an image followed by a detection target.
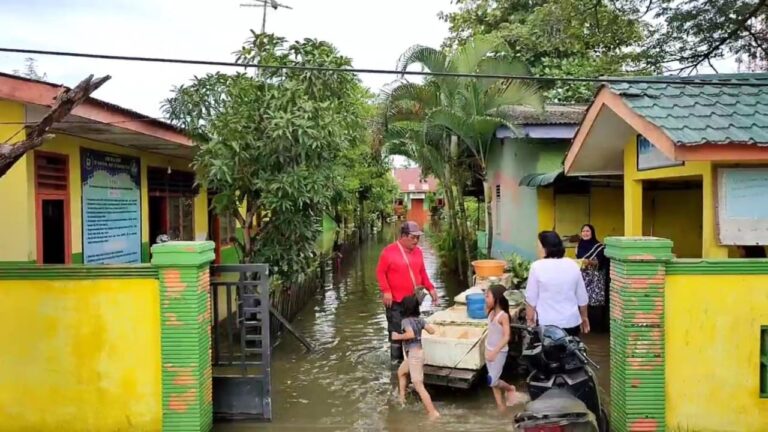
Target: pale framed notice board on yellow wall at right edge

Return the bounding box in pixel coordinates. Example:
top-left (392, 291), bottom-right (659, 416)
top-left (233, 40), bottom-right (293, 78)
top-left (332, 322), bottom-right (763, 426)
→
top-left (715, 167), bottom-right (768, 245)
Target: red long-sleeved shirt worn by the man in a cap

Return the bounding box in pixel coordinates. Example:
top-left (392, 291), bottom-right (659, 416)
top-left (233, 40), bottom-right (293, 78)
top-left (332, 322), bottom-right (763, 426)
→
top-left (376, 242), bottom-right (435, 303)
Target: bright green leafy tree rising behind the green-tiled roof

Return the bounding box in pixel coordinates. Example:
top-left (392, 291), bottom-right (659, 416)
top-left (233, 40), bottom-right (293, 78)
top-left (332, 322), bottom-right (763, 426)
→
top-left (440, 0), bottom-right (660, 102)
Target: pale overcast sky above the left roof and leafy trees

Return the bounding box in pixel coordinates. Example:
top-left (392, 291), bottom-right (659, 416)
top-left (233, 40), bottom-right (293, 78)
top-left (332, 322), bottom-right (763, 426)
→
top-left (0, 0), bottom-right (452, 116)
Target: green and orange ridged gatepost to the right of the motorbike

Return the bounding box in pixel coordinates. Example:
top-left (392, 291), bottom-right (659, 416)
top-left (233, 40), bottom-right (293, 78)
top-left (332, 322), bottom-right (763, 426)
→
top-left (605, 237), bottom-right (673, 432)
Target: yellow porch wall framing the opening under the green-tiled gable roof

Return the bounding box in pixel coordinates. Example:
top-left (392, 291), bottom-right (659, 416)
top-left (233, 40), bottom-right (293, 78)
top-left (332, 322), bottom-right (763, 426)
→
top-left (624, 136), bottom-right (728, 258)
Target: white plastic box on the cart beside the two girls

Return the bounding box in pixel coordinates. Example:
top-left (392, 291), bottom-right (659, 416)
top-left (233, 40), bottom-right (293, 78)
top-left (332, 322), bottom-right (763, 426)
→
top-left (421, 324), bottom-right (485, 370)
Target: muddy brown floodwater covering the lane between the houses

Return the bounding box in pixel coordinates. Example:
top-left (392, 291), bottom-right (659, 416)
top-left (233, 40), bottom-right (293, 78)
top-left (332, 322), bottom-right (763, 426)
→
top-left (215, 231), bottom-right (609, 432)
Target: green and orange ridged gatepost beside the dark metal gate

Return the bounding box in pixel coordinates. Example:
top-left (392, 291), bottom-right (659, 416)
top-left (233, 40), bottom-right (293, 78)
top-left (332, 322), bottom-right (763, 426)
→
top-left (152, 242), bottom-right (214, 432)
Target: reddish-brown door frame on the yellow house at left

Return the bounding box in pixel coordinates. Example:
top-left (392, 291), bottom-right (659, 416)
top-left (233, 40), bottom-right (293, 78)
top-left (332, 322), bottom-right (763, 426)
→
top-left (33, 150), bottom-right (72, 264)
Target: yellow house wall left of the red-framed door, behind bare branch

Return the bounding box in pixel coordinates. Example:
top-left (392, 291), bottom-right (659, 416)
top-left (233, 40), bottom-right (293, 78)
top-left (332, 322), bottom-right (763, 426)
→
top-left (0, 100), bottom-right (36, 262)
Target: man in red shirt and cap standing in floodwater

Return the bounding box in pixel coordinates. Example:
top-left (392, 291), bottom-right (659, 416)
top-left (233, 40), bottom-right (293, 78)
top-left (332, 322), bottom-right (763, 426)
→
top-left (376, 221), bottom-right (438, 360)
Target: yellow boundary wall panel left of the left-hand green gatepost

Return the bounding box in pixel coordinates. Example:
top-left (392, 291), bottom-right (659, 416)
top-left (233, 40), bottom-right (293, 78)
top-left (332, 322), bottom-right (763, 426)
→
top-left (0, 279), bottom-right (162, 431)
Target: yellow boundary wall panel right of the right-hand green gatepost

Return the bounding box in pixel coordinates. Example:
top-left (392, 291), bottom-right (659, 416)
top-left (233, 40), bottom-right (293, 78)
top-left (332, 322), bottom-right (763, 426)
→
top-left (665, 275), bottom-right (768, 432)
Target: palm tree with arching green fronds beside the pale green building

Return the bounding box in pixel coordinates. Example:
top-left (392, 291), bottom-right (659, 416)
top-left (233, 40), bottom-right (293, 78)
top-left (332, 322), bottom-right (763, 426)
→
top-left (387, 36), bottom-right (543, 256)
